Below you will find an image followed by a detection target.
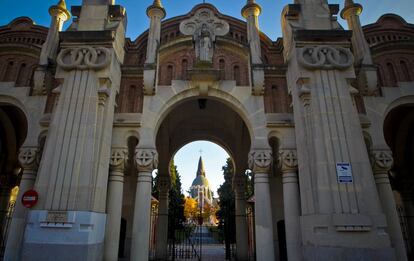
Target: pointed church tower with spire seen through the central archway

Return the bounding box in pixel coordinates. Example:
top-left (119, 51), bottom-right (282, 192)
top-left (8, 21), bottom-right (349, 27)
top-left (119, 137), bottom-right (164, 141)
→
top-left (190, 156), bottom-right (213, 206)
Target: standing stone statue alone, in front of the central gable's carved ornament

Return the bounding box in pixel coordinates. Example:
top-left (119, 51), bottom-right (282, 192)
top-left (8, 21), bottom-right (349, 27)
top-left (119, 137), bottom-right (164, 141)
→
top-left (194, 24), bottom-right (214, 62)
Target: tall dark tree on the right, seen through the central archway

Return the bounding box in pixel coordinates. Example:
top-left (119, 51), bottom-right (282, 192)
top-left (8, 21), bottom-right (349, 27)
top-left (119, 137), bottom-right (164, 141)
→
top-left (217, 158), bottom-right (236, 257)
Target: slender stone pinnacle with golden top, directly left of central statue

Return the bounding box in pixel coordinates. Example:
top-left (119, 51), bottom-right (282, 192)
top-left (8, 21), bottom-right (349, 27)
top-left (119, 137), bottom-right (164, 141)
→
top-left (144, 0), bottom-right (166, 95)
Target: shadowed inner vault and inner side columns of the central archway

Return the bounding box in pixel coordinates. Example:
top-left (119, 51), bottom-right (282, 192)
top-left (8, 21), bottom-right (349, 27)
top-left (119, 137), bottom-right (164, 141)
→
top-left (156, 96), bottom-right (252, 260)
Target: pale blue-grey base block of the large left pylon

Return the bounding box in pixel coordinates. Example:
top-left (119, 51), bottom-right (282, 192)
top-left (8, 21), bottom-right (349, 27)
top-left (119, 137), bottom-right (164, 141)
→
top-left (21, 210), bottom-right (106, 261)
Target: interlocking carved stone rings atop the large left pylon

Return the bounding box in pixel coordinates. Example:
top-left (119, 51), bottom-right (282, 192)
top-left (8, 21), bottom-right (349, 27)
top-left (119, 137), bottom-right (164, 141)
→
top-left (57, 46), bottom-right (111, 71)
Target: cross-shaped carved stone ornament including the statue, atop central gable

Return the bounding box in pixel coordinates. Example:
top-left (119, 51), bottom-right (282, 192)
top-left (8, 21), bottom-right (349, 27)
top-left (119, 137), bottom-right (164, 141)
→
top-left (180, 8), bottom-right (230, 63)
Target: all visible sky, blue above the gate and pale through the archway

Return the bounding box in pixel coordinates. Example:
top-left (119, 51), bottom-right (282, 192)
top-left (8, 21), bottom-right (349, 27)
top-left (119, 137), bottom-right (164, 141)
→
top-left (0, 0), bottom-right (414, 196)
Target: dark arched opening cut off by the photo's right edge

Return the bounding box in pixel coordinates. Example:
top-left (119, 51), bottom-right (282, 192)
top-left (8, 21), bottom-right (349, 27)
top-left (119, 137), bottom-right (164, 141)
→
top-left (384, 103), bottom-right (414, 260)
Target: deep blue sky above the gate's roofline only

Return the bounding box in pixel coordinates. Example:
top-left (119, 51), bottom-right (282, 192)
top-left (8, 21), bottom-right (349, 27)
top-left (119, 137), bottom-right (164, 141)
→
top-left (0, 0), bottom-right (414, 40)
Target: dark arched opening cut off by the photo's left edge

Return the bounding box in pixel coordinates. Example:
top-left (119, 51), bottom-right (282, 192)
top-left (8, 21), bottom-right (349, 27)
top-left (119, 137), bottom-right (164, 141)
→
top-left (0, 103), bottom-right (27, 256)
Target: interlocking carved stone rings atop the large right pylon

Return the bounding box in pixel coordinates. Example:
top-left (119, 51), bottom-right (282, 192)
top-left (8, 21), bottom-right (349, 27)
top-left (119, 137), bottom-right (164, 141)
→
top-left (298, 46), bottom-right (354, 70)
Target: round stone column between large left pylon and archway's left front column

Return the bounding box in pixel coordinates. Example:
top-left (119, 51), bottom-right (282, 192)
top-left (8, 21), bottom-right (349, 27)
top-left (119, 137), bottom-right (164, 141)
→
top-left (104, 148), bottom-right (128, 261)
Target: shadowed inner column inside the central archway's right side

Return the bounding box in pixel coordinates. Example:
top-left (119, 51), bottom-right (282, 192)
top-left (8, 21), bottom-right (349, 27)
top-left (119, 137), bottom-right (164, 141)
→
top-left (233, 175), bottom-right (249, 261)
